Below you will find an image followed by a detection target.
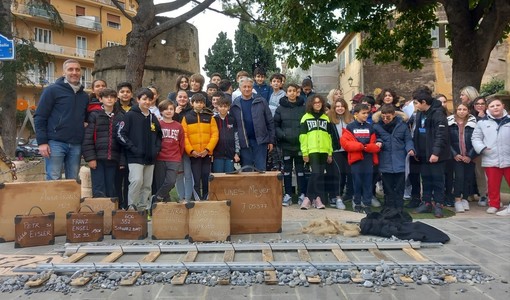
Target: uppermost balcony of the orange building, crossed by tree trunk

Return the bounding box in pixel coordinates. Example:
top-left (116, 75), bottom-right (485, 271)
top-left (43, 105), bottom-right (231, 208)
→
top-left (11, 4), bottom-right (103, 32)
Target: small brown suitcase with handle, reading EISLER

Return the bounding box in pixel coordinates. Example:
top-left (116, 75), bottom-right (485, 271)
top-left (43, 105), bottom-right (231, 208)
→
top-left (14, 206), bottom-right (55, 248)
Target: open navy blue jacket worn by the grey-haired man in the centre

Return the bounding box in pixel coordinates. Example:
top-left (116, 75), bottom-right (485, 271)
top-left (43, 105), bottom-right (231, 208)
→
top-left (230, 94), bottom-right (275, 148)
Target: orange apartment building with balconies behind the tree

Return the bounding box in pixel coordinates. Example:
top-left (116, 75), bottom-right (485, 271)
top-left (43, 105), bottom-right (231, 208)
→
top-left (11, 0), bottom-right (136, 106)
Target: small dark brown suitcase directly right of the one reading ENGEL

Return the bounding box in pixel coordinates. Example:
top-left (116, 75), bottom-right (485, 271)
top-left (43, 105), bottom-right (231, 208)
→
top-left (112, 205), bottom-right (147, 240)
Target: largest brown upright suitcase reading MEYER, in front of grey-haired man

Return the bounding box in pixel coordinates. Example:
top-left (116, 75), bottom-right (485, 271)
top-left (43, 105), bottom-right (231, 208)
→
top-left (209, 172), bottom-right (283, 234)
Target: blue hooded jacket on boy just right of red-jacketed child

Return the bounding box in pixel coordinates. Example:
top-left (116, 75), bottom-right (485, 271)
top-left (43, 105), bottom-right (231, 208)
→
top-left (373, 116), bottom-right (416, 173)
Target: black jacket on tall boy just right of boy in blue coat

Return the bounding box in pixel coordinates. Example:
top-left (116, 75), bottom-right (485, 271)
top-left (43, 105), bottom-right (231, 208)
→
top-left (413, 100), bottom-right (452, 162)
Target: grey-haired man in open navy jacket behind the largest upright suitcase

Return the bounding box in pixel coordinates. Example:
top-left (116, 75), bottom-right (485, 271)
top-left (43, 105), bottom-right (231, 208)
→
top-left (230, 77), bottom-right (275, 170)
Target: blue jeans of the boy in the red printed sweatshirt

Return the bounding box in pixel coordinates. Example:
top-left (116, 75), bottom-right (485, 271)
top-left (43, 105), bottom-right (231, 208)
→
top-left (154, 160), bottom-right (180, 202)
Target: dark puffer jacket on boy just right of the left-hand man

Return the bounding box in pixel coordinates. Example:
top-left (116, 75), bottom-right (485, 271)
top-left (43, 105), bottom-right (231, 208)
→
top-left (82, 110), bottom-right (125, 165)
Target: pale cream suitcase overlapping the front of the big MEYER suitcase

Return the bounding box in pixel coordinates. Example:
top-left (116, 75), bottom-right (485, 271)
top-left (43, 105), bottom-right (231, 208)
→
top-left (186, 201), bottom-right (231, 243)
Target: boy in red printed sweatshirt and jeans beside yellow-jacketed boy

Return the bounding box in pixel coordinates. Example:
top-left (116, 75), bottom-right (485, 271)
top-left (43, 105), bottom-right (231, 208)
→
top-left (151, 100), bottom-right (184, 203)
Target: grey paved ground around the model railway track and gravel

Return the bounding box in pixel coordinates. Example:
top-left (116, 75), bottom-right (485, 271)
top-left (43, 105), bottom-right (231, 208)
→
top-left (0, 198), bottom-right (510, 300)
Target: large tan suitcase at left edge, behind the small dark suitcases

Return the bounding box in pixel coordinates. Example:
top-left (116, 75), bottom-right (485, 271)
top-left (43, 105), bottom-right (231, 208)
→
top-left (0, 180), bottom-right (80, 242)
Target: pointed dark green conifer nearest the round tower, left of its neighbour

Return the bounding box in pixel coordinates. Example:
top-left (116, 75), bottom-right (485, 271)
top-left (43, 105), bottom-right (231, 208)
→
top-left (203, 31), bottom-right (235, 81)
